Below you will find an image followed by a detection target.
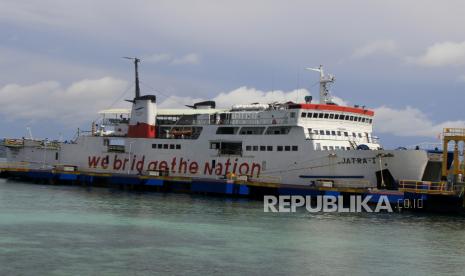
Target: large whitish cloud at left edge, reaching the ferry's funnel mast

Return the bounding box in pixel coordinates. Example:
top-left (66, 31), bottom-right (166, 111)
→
top-left (0, 77), bottom-right (128, 127)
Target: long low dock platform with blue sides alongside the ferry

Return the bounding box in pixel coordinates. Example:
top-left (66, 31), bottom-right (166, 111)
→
top-left (0, 163), bottom-right (465, 213)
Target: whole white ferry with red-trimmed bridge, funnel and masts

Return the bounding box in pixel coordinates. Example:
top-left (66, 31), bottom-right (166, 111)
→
top-left (5, 58), bottom-right (428, 188)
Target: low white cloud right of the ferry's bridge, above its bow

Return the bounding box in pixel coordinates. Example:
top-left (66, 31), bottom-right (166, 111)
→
top-left (374, 106), bottom-right (465, 137)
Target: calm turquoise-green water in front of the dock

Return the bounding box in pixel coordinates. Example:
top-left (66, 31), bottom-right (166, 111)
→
top-left (0, 179), bottom-right (465, 275)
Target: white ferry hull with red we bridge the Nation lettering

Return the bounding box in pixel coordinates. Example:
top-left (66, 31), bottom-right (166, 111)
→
top-left (7, 136), bottom-right (428, 187)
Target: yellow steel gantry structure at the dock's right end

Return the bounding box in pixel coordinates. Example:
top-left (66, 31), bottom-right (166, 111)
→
top-left (442, 128), bottom-right (465, 178)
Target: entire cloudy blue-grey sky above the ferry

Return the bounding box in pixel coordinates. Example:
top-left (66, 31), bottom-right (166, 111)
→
top-left (0, 0), bottom-right (465, 148)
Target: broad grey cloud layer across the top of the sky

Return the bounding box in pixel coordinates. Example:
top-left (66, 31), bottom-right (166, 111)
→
top-left (0, 0), bottom-right (464, 67)
